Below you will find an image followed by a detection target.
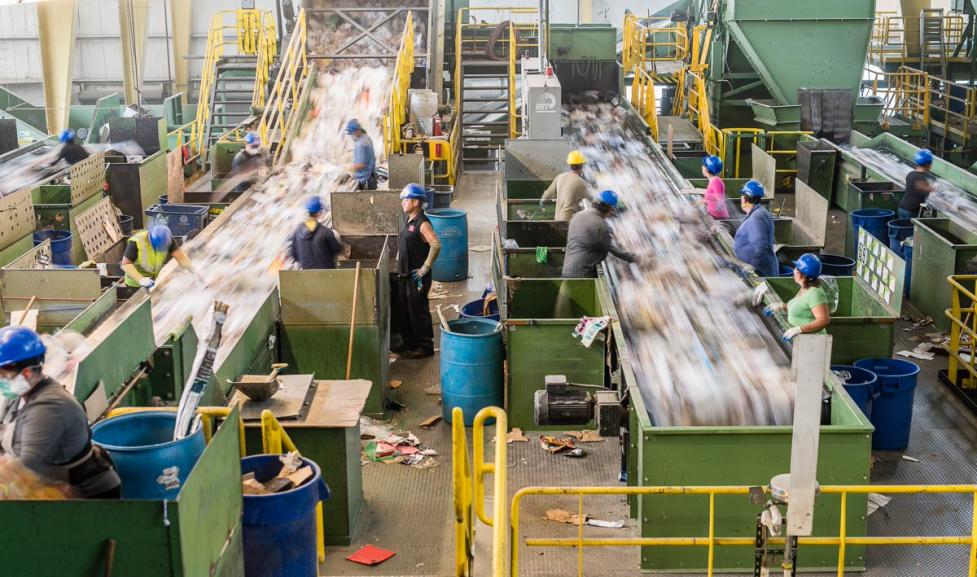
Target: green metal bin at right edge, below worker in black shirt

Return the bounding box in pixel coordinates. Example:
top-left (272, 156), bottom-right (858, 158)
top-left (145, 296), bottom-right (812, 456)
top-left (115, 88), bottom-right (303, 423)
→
top-left (909, 218), bottom-right (977, 331)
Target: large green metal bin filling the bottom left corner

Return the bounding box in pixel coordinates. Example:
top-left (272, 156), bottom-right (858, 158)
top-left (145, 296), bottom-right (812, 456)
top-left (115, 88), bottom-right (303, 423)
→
top-left (0, 409), bottom-right (244, 577)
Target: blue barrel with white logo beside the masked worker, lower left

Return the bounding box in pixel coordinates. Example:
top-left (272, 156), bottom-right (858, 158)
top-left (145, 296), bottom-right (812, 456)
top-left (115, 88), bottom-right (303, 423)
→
top-left (92, 411), bottom-right (204, 500)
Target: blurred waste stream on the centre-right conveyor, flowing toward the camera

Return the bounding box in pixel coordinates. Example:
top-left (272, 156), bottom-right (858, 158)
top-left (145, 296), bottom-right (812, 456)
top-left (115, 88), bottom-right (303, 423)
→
top-left (569, 103), bottom-right (794, 426)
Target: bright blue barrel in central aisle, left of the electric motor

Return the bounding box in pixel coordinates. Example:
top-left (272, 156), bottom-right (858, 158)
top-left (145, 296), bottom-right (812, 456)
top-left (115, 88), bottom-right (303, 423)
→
top-left (441, 318), bottom-right (504, 427)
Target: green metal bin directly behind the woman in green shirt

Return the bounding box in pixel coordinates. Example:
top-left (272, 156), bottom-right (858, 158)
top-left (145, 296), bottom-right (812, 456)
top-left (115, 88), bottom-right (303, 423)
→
top-left (766, 276), bottom-right (899, 365)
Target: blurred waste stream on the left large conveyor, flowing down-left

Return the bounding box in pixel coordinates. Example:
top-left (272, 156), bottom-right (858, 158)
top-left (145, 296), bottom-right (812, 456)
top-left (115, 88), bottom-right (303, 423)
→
top-left (47, 68), bottom-right (388, 387)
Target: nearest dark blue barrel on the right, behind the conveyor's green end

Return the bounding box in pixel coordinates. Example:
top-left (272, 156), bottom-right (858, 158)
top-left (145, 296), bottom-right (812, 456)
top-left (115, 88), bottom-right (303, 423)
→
top-left (855, 359), bottom-right (919, 451)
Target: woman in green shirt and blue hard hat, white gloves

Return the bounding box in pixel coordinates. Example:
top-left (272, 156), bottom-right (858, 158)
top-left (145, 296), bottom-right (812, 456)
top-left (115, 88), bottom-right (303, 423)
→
top-left (763, 253), bottom-right (831, 342)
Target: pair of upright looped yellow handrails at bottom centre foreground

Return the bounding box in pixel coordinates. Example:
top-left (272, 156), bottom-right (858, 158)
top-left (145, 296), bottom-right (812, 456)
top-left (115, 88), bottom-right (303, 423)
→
top-left (451, 407), bottom-right (515, 577)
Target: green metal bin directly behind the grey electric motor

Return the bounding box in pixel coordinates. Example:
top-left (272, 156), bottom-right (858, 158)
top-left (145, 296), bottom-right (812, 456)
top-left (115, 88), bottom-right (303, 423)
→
top-left (500, 279), bottom-right (606, 430)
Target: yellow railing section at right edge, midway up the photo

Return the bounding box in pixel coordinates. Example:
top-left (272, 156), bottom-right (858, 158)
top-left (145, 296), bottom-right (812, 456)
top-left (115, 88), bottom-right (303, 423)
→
top-left (945, 275), bottom-right (977, 389)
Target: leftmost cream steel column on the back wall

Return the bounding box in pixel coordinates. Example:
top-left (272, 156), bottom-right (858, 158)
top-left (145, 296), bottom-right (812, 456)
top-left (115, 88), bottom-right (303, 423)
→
top-left (37, 0), bottom-right (77, 134)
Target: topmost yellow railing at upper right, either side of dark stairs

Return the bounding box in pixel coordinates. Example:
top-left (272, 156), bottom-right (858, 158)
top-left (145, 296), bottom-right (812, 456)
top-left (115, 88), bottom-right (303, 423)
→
top-left (868, 11), bottom-right (966, 63)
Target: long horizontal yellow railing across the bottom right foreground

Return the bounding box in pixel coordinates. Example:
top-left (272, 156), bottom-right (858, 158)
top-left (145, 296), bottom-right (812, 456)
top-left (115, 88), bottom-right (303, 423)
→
top-left (508, 486), bottom-right (977, 577)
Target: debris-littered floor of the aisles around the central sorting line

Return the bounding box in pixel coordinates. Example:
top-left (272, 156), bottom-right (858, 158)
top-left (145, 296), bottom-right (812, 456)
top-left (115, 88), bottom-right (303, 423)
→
top-left (320, 177), bottom-right (977, 577)
